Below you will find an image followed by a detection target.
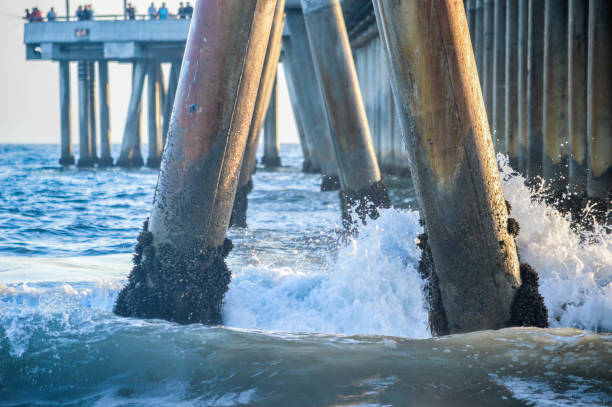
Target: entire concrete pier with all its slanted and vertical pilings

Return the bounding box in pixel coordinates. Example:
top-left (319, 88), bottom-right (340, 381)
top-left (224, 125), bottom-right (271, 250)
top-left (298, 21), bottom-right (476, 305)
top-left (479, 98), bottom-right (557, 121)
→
top-left (25, 0), bottom-right (612, 334)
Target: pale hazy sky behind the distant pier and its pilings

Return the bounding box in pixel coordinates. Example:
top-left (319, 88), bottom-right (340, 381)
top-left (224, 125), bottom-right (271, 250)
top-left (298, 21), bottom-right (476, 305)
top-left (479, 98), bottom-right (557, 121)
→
top-left (0, 0), bottom-right (298, 144)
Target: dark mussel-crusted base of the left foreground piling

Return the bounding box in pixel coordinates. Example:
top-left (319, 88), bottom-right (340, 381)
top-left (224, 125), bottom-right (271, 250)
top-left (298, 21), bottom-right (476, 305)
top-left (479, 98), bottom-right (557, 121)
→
top-left (113, 222), bottom-right (232, 325)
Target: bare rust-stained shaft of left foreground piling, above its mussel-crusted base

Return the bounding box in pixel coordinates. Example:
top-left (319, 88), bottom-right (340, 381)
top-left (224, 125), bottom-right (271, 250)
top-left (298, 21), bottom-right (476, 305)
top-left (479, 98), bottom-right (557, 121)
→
top-left (149, 0), bottom-right (276, 250)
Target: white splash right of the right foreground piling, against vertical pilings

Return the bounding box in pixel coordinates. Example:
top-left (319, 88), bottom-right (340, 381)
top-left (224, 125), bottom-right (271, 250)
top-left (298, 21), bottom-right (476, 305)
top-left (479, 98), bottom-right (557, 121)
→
top-left (498, 155), bottom-right (612, 332)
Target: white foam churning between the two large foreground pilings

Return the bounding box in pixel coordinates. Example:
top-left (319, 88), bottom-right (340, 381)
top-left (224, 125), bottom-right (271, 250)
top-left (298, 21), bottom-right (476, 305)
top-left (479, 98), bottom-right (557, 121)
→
top-left (224, 209), bottom-right (430, 338)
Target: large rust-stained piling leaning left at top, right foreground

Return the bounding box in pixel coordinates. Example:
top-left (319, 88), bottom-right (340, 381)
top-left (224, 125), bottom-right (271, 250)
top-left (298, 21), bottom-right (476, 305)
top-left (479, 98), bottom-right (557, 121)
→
top-left (374, 0), bottom-right (521, 334)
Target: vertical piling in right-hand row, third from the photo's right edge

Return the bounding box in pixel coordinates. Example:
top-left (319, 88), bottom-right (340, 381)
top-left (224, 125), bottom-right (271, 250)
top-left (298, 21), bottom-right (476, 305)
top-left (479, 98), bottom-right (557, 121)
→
top-left (542, 0), bottom-right (569, 200)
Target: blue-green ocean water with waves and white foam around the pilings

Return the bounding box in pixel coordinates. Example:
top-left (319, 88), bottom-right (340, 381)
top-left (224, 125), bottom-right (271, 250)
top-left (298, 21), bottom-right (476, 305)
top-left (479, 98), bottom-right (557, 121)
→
top-left (0, 145), bottom-right (612, 406)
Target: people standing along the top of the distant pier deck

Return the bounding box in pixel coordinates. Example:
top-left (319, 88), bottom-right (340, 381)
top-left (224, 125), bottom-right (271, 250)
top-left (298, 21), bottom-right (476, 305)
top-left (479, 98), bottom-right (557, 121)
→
top-left (24, 2), bottom-right (193, 23)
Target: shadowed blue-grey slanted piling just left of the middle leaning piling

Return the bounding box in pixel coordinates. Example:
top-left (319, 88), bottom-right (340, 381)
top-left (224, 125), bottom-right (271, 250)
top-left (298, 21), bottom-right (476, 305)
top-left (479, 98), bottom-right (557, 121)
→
top-left (283, 10), bottom-right (340, 185)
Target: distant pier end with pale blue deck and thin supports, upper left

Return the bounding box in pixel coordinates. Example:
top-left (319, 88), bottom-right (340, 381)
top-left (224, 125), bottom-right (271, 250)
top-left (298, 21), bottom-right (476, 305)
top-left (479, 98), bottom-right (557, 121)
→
top-left (24, 15), bottom-right (191, 167)
